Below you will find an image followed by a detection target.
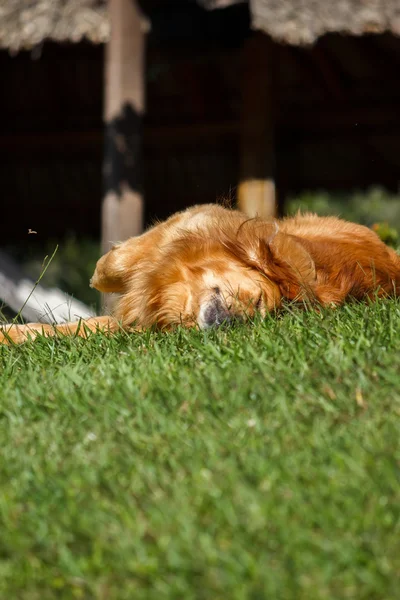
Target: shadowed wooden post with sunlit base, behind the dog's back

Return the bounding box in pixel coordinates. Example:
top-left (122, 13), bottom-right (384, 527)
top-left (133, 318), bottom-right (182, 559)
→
top-left (238, 32), bottom-right (277, 218)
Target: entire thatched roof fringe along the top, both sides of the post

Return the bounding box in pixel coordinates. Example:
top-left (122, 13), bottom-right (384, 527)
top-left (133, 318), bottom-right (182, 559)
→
top-left (0, 0), bottom-right (400, 51)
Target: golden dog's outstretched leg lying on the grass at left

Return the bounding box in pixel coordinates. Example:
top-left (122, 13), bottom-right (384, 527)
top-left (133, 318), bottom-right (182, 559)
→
top-left (0, 317), bottom-right (121, 345)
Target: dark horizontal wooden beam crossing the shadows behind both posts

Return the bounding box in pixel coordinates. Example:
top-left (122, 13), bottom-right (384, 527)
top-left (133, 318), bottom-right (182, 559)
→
top-left (0, 103), bottom-right (400, 160)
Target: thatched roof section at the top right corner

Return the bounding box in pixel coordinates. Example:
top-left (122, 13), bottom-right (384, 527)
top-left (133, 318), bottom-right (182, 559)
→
top-left (200, 0), bottom-right (400, 45)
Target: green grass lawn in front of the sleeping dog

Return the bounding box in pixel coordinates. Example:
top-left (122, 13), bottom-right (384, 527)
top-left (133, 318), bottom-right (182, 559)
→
top-left (0, 301), bottom-right (400, 600)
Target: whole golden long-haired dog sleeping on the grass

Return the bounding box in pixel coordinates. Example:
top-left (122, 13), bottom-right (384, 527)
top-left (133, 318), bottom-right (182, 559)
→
top-left (0, 205), bottom-right (400, 343)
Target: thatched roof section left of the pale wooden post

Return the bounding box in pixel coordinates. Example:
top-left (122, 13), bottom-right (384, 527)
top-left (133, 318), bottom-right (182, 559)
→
top-left (0, 0), bottom-right (110, 51)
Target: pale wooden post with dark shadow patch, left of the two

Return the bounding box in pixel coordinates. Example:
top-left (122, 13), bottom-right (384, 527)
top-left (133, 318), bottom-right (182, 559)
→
top-left (102, 0), bottom-right (146, 252)
